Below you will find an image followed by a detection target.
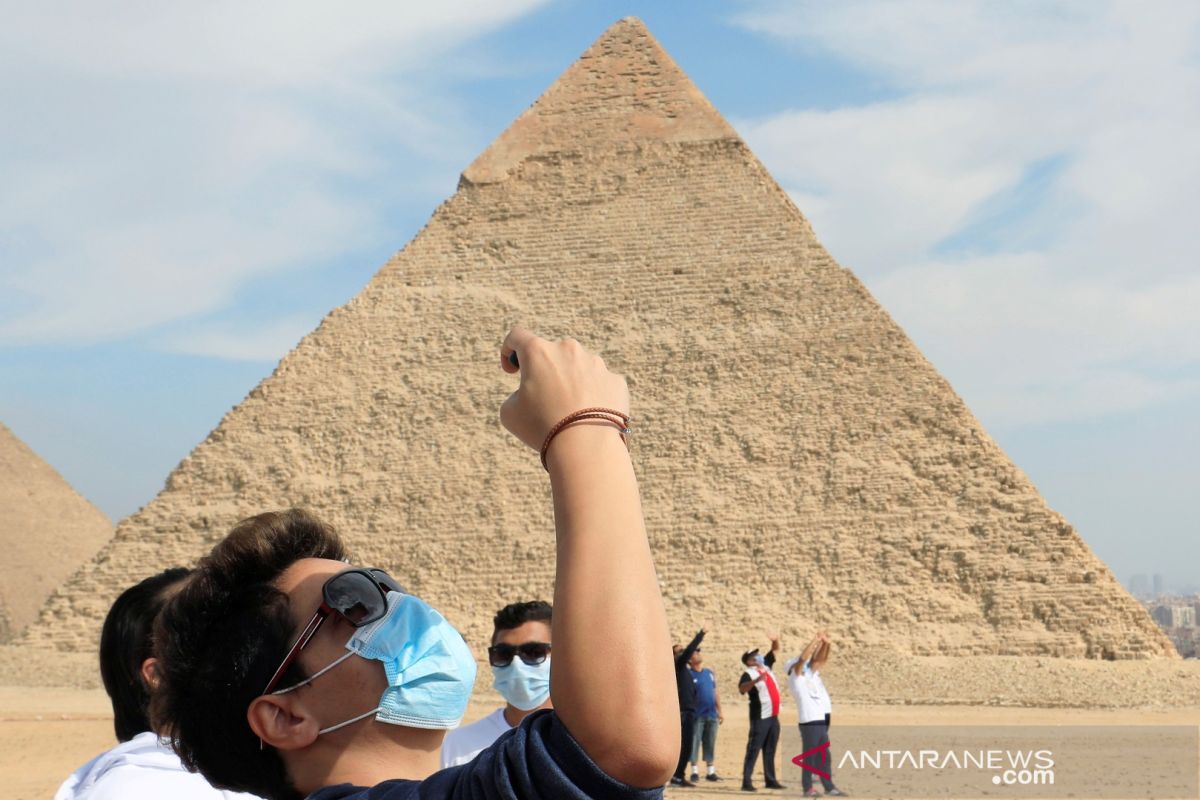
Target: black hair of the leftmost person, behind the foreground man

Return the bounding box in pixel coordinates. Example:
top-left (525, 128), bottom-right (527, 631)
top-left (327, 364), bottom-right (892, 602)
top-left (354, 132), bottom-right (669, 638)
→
top-left (100, 566), bottom-right (191, 741)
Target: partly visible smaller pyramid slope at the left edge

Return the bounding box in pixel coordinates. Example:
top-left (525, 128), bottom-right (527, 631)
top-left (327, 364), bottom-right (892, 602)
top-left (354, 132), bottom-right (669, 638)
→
top-left (0, 425), bottom-right (113, 643)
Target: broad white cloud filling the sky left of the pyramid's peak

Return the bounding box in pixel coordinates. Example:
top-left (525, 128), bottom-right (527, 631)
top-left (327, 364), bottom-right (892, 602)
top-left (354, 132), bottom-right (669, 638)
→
top-left (0, 0), bottom-right (542, 347)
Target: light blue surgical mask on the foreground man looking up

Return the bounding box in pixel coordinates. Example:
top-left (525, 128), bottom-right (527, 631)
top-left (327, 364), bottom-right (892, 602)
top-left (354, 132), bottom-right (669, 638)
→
top-left (275, 591), bottom-right (475, 733)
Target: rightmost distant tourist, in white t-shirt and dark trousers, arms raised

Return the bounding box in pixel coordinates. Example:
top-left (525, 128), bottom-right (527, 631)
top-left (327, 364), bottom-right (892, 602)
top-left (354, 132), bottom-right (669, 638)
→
top-left (785, 631), bottom-right (844, 798)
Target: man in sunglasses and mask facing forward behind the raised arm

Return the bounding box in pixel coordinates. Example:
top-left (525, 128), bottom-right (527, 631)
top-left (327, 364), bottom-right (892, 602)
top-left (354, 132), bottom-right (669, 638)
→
top-left (442, 600), bottom-right (553, 768)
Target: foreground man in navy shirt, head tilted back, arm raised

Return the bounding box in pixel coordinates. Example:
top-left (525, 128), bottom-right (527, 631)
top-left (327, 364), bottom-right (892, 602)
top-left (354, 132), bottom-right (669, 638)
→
top-left (154, 329), bottom-right (679, 800)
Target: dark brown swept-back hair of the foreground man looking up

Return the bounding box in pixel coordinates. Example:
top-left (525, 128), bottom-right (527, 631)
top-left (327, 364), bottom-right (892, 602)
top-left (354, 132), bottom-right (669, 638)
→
top-left (151, 509), bottom-right (346, 800)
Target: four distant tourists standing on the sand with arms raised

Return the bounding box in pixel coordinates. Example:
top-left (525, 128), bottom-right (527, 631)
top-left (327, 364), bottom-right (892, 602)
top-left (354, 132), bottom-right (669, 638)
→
top-left (671, 626), bottom-right (845, 796)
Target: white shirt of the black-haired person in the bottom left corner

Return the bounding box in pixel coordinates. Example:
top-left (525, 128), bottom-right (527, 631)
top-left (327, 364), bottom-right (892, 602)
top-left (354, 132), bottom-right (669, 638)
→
top-left (54, 730), bottom-right (256, 800)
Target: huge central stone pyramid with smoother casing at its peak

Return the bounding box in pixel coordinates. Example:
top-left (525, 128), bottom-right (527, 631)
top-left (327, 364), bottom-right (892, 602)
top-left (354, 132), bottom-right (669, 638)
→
top-left (26, 19), bottom-right (1174, 658)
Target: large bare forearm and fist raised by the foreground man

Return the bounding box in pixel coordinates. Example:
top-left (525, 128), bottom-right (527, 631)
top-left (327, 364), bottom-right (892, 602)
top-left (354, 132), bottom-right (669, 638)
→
top-left (500, 329), bottom-right (679, 787)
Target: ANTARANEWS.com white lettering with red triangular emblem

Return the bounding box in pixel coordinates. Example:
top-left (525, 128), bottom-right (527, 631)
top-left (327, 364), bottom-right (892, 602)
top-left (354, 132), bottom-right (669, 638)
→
top-left (792, 742), bottom-right (1055, 786)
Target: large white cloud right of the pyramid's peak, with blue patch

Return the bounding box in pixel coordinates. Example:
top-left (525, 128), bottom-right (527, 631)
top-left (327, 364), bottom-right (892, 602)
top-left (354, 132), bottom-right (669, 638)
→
top-left (738, 1), bottom-right (1200, 426)
